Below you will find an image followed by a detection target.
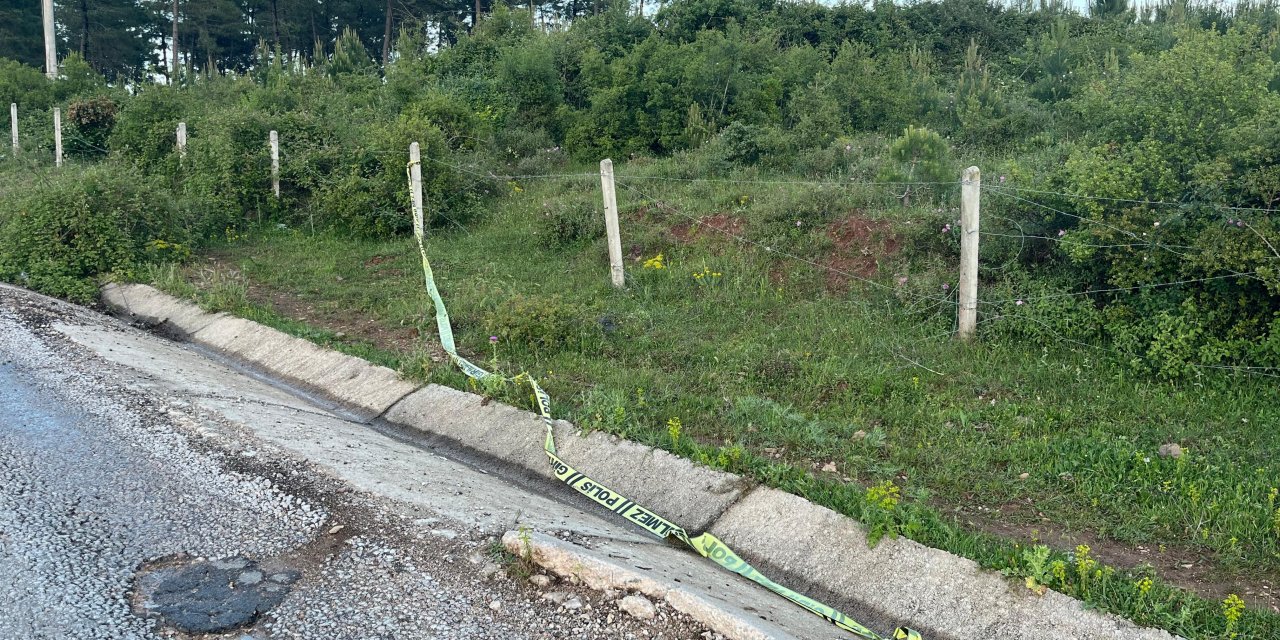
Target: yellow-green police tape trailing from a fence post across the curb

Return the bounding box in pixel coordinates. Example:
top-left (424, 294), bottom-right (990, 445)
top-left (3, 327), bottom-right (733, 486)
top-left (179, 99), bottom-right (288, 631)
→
top-left (413, 162), bottom-right (922, 640)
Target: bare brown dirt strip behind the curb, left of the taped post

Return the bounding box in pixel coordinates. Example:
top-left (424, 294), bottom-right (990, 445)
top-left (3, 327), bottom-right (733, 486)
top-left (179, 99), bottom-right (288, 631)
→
top-left (190, 255), bottom-right (424, 360)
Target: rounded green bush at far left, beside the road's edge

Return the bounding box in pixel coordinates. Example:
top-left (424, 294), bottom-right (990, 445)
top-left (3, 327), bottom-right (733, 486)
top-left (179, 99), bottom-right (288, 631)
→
top-left (0, 165), bottom-right (188, 302)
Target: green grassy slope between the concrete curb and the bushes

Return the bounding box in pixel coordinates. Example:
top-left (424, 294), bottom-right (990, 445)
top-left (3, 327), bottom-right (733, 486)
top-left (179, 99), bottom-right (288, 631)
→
top-left (147, 163), bottom-right (1280, 639)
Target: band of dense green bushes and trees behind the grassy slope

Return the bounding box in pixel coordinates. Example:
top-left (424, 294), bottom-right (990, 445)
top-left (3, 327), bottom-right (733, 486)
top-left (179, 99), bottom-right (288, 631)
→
top-left (0, 0), bottom-right (1280, 378)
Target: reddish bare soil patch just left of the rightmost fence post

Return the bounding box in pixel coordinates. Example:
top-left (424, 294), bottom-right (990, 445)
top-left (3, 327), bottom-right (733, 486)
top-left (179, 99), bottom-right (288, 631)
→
top-left (820, 211), bottom-right (901, 293)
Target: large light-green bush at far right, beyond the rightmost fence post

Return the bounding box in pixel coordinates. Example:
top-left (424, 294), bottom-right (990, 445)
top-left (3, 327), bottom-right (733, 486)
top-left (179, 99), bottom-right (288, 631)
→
top-left (1021, 28), bottom-right (1280, 378)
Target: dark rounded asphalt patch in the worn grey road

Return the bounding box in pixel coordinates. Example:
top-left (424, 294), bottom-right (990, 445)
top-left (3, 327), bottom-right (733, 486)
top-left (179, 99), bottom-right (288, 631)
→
top-left (136, 557), bottom-right (301, 634)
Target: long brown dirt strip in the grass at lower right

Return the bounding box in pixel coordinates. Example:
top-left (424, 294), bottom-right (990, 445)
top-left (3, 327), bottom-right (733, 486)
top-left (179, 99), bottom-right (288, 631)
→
top-left (952, 503), bottom-right (1280, 613)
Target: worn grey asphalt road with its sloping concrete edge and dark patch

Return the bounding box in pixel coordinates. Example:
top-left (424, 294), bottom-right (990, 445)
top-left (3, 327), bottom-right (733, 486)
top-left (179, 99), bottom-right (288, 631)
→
top-left (0, 287), bottom-right (717, 640)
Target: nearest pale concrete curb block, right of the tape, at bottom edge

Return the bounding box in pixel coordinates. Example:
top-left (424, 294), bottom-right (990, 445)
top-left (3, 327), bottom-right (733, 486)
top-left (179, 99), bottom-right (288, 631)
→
top-left (712, 489), bottom-right (1174, 640)
